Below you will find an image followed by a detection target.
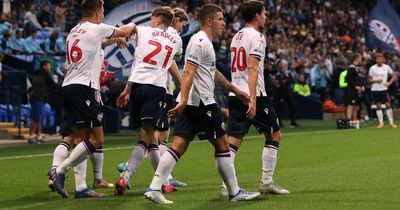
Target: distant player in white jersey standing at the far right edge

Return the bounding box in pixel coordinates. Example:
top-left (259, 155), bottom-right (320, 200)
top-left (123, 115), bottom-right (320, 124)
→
top-left (368, 52), bottom-right (397, 128)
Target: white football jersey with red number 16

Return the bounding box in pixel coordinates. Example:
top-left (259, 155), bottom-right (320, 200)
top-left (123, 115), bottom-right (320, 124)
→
top-left (62, 22), bottom-right (116, 89)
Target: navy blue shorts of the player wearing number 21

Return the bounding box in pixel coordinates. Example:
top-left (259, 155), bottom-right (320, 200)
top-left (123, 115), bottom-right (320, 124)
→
top-left (130, 83), bottom-right (165, 129)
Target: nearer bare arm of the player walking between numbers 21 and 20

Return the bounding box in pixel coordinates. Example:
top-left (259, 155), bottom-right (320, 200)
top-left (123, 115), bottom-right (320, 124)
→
top-left (168, 62), bottom-right (198, 118)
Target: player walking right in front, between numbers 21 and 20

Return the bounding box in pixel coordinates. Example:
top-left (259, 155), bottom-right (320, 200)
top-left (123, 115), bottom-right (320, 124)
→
top-left (145, 4), bottom-right (260, 204)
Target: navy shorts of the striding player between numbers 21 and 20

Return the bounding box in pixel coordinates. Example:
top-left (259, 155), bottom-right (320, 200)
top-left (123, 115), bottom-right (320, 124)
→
top-left (174, 102), bottom-right (225, 140)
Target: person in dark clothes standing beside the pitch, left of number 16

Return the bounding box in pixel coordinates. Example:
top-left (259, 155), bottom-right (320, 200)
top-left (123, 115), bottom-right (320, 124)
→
top-left (28, 60), bottom-right (59, 144)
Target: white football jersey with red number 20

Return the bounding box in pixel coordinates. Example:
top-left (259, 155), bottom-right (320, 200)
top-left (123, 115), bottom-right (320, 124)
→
top-left (229, 27), bottom-right (267, 96)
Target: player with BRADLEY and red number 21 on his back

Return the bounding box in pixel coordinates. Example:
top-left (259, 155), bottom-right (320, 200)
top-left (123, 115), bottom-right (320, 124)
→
top-left (114, 7), bottom-right (182, 195)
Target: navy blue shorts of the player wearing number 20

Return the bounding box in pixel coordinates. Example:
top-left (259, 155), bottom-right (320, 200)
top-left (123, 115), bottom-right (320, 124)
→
top-left (227, 96), bottom-right (280, 135)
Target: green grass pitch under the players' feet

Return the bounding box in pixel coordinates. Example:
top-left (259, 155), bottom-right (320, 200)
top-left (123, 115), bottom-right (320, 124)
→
top-left (0, 121), bottom-right (400, 209)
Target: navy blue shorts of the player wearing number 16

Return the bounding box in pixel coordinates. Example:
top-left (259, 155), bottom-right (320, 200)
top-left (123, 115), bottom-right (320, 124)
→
top-left (62, 84), bottom-right (103, 129)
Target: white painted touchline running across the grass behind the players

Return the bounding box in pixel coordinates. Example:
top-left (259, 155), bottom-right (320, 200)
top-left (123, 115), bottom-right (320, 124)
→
top-left (0, 127), bottom-right (373, 160)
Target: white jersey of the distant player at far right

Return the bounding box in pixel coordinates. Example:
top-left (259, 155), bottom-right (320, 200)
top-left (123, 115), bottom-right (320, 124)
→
top-left (368, 64), bottom-right (393, 91)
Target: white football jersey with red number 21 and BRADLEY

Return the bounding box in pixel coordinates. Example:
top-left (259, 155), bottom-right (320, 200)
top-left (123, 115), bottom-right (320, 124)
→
top-left (129, 26), bottom-right (182, 88)
